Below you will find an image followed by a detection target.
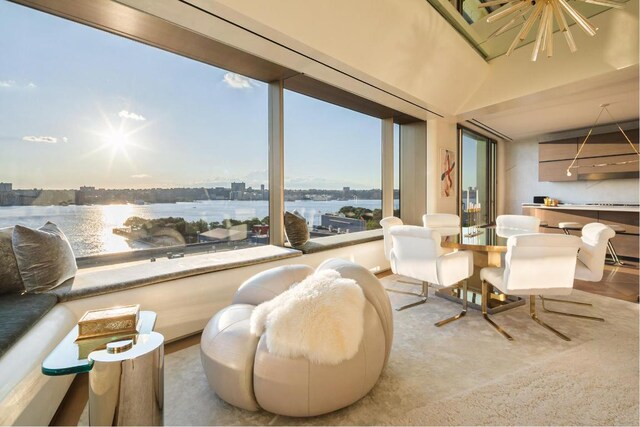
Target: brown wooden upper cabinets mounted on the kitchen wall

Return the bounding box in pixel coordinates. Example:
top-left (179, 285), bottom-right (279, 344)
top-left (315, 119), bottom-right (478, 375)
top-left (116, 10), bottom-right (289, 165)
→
top-left (538, 129), bottom-right (640, 182)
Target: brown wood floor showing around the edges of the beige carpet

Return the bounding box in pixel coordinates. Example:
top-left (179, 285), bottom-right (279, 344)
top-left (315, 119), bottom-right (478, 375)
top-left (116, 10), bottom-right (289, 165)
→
top-left (50, 261), bottom-right (640, 426)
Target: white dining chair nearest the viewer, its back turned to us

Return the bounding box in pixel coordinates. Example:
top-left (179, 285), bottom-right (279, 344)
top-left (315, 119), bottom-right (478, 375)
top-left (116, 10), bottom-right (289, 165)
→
top-left (480, 234), bottom-right (602, 341)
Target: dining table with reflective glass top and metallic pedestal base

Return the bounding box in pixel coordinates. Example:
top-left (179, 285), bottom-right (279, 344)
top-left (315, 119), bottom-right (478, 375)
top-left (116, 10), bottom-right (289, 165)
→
top-left (436, 226), bottom-right (525, 314)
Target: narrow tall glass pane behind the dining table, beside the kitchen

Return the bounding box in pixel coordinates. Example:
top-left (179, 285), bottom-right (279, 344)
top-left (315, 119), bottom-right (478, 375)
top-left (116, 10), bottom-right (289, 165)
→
top-left (459, 128), bottom-right (496, 227)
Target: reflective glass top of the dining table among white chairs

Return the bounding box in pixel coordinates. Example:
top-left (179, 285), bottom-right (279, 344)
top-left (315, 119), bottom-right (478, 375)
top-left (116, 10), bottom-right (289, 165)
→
top-left (442, 227), bottom-right (523, 252)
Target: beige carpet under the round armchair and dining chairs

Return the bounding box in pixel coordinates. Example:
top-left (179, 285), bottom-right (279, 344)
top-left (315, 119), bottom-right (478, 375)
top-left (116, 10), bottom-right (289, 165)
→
top-left (81, 276), bottom-right (639, 425)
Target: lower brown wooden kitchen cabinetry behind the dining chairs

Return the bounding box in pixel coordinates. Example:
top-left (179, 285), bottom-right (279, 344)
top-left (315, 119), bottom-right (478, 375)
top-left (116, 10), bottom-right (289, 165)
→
top-left (522, 207), bottom-right (640, 259)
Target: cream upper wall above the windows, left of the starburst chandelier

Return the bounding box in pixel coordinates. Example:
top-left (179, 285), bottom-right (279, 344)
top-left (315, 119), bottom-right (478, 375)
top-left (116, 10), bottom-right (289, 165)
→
top-left (206, 0), bottom-right (489, 115)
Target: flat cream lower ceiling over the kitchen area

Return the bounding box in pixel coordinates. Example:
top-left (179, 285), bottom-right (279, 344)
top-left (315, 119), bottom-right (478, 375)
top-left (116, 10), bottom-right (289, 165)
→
top-left (462, 66), bottom-right (640, 141)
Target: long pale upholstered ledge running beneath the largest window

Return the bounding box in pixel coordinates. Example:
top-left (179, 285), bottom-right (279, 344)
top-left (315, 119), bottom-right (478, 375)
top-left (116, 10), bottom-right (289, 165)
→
top-left (50, 245), bottom-right (302, 302)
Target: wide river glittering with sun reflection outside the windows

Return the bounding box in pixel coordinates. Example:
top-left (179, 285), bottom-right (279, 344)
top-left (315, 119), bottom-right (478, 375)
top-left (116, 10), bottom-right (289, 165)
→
top-left (0, 200), bottom-right (398, 256)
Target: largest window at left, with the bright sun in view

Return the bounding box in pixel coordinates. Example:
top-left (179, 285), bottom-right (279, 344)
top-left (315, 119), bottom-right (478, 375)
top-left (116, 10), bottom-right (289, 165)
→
top-left (0, 1), bottom-right (268, 257)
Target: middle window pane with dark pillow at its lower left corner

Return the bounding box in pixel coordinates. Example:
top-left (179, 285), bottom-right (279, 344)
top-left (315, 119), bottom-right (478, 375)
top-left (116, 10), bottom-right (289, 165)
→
top-left (284, 90), bottom-right (382, 237)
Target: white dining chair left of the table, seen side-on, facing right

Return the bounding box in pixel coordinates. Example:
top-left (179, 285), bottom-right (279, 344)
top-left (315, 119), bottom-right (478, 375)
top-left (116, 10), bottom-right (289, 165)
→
top-left (390, 225), bottom-right (473, 326)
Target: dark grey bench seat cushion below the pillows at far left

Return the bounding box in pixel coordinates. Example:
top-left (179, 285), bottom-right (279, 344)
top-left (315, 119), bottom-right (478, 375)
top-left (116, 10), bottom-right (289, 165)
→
top-left (0, 294), bottom-right (58, 357)
